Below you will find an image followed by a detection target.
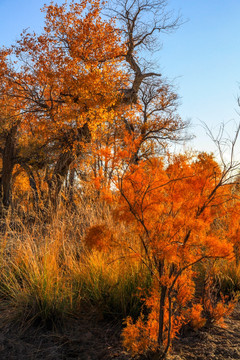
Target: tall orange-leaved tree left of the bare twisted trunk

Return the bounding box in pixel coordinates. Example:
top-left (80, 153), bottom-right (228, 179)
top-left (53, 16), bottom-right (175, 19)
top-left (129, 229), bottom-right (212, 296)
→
top-left (2, 1), bottom-right (124, 208)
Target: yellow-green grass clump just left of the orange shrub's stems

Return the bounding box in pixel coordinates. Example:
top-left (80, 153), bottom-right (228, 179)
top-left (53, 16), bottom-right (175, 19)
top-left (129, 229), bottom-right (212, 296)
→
top-left (67, 251), bottom-right (151, 318)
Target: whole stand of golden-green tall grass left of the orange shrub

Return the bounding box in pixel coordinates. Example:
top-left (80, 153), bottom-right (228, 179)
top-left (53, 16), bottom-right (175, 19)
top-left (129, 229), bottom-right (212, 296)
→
top-left (0, 198), bottom-right (151, 327)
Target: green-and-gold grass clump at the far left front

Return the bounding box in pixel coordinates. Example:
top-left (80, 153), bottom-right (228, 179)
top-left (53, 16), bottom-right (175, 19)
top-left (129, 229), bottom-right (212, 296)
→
top-left (0, 235), bottom-right (75, 326)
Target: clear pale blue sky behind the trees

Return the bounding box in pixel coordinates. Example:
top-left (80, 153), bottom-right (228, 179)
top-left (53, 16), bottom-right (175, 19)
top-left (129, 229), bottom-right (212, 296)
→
top-left (0, 0), bottom-right (240, 155)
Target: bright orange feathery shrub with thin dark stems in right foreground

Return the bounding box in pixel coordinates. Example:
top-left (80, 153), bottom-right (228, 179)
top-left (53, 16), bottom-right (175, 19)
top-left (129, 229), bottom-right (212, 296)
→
top-left (118, 148), bottom-right (239, 358)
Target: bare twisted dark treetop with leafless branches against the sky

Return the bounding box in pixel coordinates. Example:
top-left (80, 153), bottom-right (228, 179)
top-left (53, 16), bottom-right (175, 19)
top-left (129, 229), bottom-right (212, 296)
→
top-left (107, 0), bottom-right (182, 103)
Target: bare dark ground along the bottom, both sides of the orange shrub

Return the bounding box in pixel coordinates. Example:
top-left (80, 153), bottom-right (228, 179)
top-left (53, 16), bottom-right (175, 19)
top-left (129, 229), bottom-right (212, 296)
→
top-left (0, 306), bottom-right (240, 360)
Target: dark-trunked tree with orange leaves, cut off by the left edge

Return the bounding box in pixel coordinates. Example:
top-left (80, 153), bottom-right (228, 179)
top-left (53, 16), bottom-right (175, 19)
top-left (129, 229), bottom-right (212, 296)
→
top-left (0, 50), bottom-right (52, 216)
